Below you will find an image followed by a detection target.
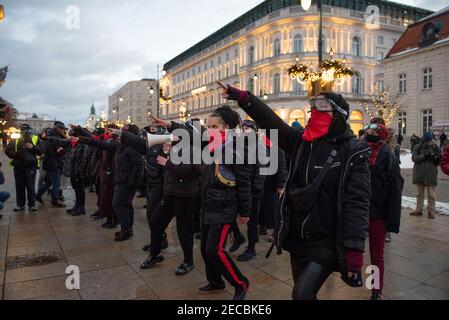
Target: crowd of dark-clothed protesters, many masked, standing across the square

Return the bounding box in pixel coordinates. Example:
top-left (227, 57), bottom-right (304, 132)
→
top-left (0, 83), bottom-right (449, 300)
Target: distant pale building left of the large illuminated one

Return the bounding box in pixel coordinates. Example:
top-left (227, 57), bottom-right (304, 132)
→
top-left (108, 79), bottom-right (159, 128)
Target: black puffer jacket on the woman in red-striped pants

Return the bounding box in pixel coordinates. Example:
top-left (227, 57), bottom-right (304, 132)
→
top-left (171, 122), bottom-right (252, 224)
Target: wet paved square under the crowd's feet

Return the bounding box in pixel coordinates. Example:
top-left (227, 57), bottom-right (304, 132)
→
top-left (0, 155), bottom-right (449, 300)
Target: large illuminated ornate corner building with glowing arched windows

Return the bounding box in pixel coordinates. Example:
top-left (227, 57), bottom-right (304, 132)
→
top-left (161, 0), bottom-right (431, 132)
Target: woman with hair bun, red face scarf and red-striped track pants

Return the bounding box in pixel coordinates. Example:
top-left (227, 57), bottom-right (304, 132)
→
top-left (149, 106), bottom-right (251, 300)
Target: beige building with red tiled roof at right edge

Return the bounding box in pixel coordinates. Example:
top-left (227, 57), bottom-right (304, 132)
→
top-left (383, 7), bottom-right (449, 142)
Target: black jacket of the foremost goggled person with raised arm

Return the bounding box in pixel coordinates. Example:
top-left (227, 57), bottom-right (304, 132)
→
top-left (236, 94), bottom-right (371, 272)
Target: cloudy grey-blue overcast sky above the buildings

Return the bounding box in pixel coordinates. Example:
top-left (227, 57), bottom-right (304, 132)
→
top-left (0, 0), bottom-right (449, 123)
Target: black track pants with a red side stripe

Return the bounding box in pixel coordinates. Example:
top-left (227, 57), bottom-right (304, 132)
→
top-left (201, 224), bottom-right (249, 290)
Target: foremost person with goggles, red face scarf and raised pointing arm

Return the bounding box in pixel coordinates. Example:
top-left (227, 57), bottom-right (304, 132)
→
top-left (218, 82), bottom-right (371, 300)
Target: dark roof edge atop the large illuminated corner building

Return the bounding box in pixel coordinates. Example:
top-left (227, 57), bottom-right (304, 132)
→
top-left (164, 0), bottom-right (433, 70)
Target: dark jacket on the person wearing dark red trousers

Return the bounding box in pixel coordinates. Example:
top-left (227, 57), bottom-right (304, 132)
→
top-left (370, 145), bottom-right (404, 233)
